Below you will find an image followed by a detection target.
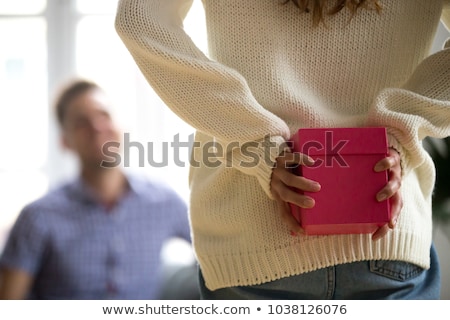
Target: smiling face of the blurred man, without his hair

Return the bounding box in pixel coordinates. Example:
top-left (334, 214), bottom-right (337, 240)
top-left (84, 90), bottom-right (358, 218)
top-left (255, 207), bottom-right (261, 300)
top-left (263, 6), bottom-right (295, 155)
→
top-left (63, 89), bottom-right (120, 167)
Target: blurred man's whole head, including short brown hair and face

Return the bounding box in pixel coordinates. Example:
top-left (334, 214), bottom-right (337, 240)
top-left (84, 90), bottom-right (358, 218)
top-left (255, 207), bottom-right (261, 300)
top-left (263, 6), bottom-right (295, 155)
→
top-left (55, 80), bottom-right (120, 168)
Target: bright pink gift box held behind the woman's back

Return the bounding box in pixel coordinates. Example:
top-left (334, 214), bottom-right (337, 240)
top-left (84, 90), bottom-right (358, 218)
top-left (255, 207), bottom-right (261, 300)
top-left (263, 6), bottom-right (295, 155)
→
top-left (291, 127), bottom-right (390, 235)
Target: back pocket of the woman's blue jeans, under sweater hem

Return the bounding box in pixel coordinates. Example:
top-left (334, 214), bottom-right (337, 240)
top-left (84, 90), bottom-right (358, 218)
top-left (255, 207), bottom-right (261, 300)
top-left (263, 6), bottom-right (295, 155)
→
top-left (369, 260), bottom-right (424, 281)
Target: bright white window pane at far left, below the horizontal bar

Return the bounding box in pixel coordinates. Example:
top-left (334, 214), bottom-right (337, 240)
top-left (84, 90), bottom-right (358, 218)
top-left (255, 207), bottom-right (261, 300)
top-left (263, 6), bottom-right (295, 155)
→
top-left (0, 18), bottom-right (48, 170)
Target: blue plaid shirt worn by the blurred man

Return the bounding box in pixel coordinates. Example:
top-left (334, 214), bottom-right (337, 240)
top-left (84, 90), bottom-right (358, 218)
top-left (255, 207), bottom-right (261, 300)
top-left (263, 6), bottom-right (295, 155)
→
top-left (0, 176), bottom-right (190, 299)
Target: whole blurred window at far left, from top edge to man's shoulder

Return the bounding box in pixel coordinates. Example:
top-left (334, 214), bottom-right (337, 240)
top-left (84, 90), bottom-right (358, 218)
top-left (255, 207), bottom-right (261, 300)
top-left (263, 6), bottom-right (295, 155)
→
top-left (0, 0), bottom-right (49, 247)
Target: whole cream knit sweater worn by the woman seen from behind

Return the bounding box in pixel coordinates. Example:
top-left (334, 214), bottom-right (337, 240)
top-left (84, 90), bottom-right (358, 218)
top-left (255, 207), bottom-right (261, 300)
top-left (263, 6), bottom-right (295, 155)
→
top-left (116, 0), bottom-right (450, 290)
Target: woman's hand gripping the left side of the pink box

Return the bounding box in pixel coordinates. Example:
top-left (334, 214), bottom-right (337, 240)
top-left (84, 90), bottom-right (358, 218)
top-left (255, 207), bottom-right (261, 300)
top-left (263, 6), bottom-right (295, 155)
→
top-left (270, 152), bottom-right (320, 234)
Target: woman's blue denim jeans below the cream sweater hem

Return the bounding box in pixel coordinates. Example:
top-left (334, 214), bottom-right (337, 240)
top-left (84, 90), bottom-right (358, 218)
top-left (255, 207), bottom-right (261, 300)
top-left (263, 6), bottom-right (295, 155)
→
top-left (200, 246), bottom-right (441, 300)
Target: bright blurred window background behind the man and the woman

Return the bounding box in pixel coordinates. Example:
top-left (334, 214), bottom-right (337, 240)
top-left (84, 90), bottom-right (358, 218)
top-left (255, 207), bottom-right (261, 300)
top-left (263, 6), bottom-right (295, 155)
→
top-left (0, 0), bottom-right (450, 299)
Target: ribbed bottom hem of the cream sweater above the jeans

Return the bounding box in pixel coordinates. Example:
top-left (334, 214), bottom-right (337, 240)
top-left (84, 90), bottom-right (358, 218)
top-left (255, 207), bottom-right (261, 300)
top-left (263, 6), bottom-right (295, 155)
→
top-left (197, 230), bottom-right (431, 290)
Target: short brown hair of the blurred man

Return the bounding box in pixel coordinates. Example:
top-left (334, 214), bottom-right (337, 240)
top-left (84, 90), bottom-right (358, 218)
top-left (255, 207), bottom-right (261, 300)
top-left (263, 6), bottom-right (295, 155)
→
top-left (55, 79), bottom-right (102, 128)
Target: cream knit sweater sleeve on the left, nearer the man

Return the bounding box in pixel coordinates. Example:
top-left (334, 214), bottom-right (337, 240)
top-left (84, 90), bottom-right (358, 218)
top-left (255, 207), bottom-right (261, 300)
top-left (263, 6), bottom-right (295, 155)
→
top-left (115, 0), bottom-right (290, 196)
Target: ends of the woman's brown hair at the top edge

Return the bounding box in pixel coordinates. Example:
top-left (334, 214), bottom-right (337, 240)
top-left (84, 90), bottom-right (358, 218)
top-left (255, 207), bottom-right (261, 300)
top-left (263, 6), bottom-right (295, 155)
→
top-left (283, 0), bottom-right (381, 25)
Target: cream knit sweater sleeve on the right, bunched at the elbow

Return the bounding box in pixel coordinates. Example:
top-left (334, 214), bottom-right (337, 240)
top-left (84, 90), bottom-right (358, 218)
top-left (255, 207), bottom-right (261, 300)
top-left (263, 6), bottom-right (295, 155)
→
top-left (368, 6), bottom-right (450, 174)
